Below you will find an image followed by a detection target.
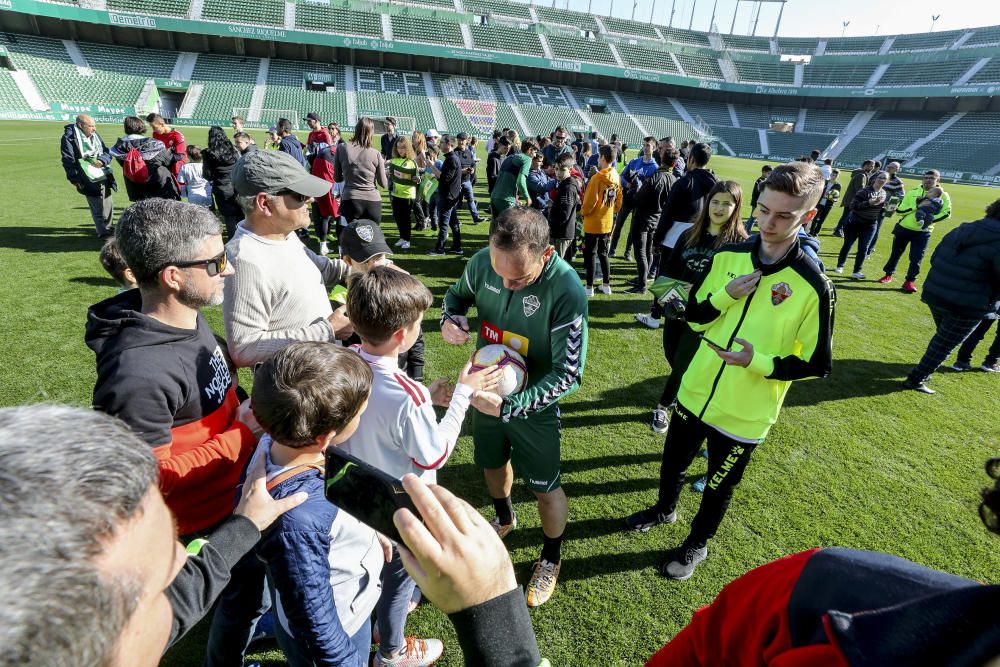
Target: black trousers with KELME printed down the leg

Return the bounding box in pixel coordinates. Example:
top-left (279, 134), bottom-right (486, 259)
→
top-left (656, 404), bottom-right (757, 547)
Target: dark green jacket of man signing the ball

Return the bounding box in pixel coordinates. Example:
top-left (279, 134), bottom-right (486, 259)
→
top-left (444, 248), bottom-right (587, 422)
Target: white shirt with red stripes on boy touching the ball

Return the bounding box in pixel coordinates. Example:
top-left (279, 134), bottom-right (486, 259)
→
top-left (340, 348), bottom-right (472, 484)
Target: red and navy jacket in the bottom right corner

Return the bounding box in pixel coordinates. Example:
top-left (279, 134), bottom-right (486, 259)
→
top-left (646, 547), bottom-right (1000, 667)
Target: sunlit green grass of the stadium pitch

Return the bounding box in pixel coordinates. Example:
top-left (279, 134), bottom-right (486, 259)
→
top-left (0, 123), bottom-right (1000, 666)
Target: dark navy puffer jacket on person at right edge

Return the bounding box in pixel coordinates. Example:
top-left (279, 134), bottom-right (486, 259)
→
top-left (921, 218), bottom-right (1000, 317)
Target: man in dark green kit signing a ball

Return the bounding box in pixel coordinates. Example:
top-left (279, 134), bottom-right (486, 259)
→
top-left (441, 207), bottom-right (587, 607)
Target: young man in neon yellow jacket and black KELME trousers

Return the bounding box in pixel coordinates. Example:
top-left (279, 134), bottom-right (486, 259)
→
top-left (625, 162), bottom-right (835, 580)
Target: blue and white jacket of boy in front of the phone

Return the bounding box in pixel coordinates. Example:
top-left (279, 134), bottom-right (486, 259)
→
top-left (256, 436), bottom-right (384, 667)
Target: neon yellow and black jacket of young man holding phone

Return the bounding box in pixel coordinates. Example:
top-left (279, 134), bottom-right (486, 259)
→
top-left (677, 237), bottom-right (836, 442)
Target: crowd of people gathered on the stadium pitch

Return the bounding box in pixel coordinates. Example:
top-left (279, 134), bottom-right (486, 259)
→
top-left (31, 114), bottom-right (1000, 666)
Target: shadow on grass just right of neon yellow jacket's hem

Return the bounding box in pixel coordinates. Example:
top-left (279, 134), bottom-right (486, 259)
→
top-left (785, 358), bottom-right (917, 405)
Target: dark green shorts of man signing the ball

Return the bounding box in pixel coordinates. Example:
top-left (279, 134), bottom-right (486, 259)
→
top-left (472, 406), bottom-right (562, 493)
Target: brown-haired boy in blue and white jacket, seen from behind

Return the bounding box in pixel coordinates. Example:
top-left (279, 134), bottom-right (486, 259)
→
top-left (252, 342), bottom-right (391, 667)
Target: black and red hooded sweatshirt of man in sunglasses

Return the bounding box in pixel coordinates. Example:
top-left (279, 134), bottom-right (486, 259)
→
top-left (86, 289), bottom-right (257, 535)
